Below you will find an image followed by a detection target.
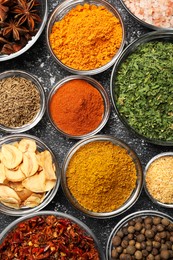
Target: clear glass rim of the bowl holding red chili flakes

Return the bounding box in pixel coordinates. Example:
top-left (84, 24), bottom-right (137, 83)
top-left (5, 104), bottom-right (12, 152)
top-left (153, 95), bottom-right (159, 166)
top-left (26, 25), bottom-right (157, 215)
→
top-left (0, 211), bottom-right (105, 260)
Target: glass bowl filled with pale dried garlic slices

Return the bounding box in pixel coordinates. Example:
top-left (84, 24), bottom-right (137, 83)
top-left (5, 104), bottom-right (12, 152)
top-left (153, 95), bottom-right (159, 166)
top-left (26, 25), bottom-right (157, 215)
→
top-left (0, 134), bottom-right (61, 216)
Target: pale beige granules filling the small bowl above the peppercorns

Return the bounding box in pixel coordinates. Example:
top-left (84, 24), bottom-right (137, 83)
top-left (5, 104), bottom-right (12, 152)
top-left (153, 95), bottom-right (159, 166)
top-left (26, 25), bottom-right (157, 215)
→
top-left (145, 155), bottom-right (173, 204)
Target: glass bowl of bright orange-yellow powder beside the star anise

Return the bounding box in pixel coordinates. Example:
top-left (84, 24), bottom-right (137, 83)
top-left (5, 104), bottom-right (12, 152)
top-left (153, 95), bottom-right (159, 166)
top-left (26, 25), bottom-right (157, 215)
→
top-left (47, 0), bottom-right (125, 75)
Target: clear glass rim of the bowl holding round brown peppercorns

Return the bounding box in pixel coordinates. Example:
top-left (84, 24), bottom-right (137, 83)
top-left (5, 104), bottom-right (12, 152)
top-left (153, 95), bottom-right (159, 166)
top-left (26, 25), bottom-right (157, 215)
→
top-left (106, 210), bottom-right (173, 260)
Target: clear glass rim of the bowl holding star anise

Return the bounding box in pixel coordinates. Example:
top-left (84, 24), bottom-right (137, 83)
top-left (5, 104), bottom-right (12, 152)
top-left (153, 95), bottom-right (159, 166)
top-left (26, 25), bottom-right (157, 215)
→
top-left (0, 0), bottom-right (48, 61)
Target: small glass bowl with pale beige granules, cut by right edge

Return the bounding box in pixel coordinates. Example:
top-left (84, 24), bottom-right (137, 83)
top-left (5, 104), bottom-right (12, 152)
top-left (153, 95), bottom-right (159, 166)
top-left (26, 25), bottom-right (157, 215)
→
top-left (144, 152), bottom-right (173, 208)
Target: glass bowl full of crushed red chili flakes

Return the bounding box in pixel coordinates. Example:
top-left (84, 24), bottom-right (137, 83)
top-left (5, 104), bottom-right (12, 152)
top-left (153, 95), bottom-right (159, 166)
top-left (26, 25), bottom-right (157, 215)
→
top-left (0, 211), bottom-right (105, 260)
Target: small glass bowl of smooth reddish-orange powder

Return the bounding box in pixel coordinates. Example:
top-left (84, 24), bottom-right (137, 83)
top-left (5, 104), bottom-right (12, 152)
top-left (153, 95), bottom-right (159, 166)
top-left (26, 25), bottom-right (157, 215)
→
top-left (47, 75), bottom-right (110, 139)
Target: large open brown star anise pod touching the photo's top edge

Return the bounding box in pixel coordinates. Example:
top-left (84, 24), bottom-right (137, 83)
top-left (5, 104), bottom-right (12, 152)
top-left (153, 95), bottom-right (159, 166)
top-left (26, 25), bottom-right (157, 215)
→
top-left (12, 0), bottom-right (41, 31)
